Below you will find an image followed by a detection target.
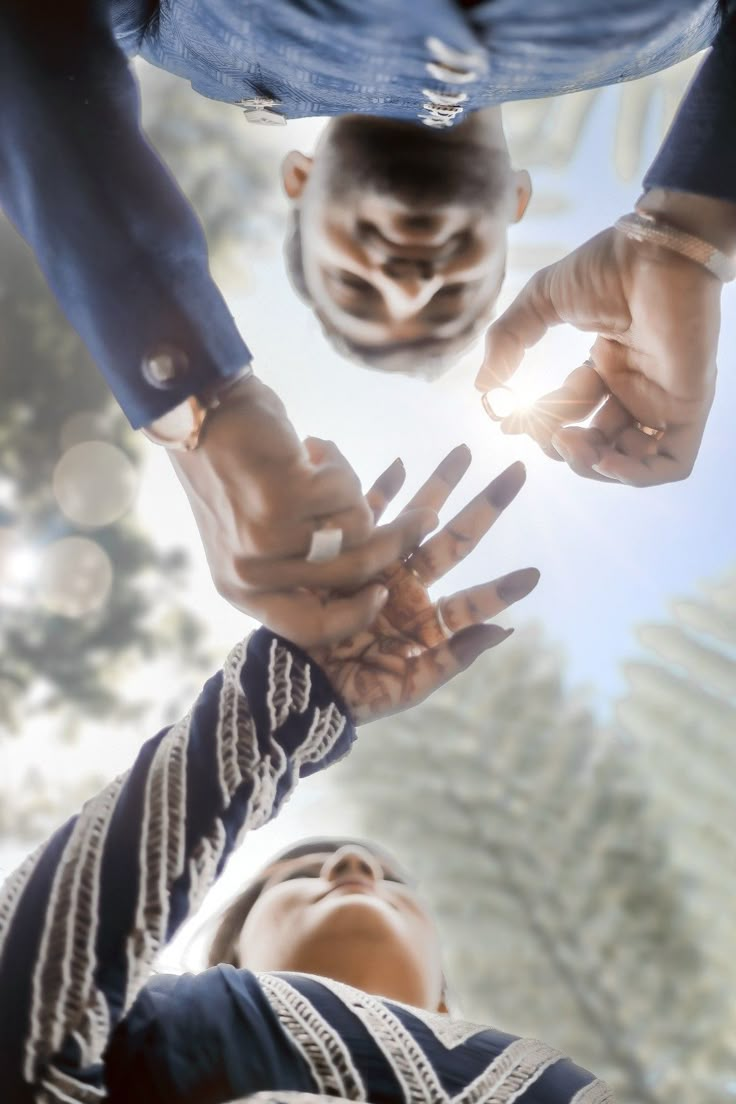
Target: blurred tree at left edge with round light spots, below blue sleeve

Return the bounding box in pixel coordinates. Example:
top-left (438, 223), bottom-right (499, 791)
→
top-left (0, 223), bottom-right (212, 731)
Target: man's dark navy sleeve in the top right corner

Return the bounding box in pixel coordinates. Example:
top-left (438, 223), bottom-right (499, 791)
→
top-left (644, 15), bottom-right (736, 203)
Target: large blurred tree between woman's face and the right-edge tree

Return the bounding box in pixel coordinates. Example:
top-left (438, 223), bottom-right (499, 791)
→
top-left (332, 633), bottom-right (726, 1104)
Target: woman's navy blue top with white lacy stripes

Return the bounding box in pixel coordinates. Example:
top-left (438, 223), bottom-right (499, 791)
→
top-left (0, 629), bottom-right (611, 1104)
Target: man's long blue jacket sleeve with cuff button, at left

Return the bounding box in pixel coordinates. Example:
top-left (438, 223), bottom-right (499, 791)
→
top-left (0, 0), bottom-right (250, 427)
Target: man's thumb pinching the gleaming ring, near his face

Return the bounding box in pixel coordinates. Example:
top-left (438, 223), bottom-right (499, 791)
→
top-left (476, 265), bottom-right (562, 391)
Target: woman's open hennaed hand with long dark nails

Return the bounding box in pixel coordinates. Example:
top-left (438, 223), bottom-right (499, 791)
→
top-left (310, 445), bottom-right (540, 723)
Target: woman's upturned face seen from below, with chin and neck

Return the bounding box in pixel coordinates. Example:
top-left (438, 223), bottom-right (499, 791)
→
top-left (238, 843), bottom-right (442, 1010)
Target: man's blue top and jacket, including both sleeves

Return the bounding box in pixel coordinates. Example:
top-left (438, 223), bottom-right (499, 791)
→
top-left (0, 0), bottom-right (736, 426)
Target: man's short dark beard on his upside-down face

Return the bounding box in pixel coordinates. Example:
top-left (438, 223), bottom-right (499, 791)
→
top-left (324, 115), bottom-right (511, 212)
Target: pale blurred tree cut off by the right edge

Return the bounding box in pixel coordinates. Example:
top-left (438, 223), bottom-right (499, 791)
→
top-left (617, 570), bottom-right (736, 1092)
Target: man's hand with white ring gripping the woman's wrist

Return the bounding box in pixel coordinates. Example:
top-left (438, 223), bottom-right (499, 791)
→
top-left (169, 376), bottom-right (437, 647)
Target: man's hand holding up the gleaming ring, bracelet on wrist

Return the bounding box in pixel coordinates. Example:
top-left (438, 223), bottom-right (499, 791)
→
top-left (476, 197), bottom-right (736, 487)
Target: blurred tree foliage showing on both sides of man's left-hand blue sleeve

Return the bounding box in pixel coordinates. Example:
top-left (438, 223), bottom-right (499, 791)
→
top-left (0, 71), bottom-right (278, 732)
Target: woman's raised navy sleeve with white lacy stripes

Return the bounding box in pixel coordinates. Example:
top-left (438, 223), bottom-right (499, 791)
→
top-left (0, 629), bottom-right (354, 1104)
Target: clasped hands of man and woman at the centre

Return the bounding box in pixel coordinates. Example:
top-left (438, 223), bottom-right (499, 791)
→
top-left (170, 378), bottom-right (538, 662)
